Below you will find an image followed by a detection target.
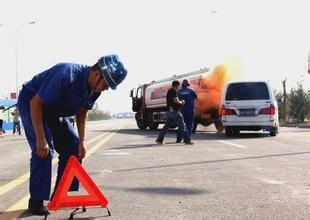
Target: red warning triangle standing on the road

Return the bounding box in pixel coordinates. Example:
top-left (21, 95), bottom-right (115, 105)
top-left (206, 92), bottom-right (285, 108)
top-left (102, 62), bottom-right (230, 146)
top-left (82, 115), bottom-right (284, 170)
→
top-left (47, 156), bottom-right (109, 211)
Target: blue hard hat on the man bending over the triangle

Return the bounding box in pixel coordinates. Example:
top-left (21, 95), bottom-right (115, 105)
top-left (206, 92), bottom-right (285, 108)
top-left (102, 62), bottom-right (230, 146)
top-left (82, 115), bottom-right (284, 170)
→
top-left (98, 55), bottom-right (127, 90)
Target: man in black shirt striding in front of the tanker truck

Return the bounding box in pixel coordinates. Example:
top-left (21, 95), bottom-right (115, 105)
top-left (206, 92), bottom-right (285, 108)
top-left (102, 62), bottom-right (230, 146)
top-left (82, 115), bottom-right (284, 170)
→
top-left (156, 81), bottom-right (194, 145)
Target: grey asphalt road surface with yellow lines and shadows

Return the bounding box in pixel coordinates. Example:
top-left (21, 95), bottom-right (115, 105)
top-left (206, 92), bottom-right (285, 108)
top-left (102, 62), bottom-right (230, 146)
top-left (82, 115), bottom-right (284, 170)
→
top-left (0, 120), bottom-right (310, 219)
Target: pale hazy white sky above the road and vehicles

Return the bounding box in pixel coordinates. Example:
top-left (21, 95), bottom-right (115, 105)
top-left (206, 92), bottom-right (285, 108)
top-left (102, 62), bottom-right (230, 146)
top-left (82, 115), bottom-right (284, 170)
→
top-left (0, 0), bottom-right (310, 113)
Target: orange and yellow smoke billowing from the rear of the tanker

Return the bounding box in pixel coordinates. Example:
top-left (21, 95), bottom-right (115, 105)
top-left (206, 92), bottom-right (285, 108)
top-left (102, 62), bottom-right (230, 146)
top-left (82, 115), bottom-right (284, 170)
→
top-left (195, 60), bottom-right (241, 116)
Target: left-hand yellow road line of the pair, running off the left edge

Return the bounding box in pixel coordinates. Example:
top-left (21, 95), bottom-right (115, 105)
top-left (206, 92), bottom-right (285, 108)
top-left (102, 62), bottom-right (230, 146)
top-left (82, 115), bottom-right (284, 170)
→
top-left (0, 129), bottom-right (109, 196)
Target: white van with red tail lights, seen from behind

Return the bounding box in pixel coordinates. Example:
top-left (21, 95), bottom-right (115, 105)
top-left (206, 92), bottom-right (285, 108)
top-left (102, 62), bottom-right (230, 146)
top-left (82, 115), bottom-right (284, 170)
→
top-left (221, 81), bottom-right (279, 136)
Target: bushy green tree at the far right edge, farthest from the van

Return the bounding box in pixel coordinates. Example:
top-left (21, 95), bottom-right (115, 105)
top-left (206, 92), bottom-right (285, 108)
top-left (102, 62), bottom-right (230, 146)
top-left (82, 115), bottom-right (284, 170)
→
top-left (288, 83), bottom-right (310, 122)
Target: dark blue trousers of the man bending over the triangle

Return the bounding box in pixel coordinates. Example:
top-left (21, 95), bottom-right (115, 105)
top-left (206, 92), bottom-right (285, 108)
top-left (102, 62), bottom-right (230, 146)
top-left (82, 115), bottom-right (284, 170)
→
top-left (18, 89), bottom-right (81, 200)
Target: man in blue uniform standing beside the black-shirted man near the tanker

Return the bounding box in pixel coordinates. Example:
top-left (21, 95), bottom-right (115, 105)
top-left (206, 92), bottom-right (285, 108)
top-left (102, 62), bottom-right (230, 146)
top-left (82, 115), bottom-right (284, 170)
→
top-left (177, 79), bottom-right (198, 143)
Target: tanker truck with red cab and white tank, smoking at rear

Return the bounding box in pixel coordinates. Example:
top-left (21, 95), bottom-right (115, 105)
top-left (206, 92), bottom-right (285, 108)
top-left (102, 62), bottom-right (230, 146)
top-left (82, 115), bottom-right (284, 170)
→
top-left (130, 67), bottom-right (224, 133)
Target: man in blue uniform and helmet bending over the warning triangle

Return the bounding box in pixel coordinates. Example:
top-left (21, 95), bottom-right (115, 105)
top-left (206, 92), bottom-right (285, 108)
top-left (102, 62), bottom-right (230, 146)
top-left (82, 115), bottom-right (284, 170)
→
top-left (18, 55), bottom-right (127, 215)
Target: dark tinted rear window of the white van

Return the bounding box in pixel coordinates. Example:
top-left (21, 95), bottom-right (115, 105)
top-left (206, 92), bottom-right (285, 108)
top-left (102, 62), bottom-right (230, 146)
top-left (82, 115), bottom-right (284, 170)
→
top-left (226, 82), bottom-right (270, 101)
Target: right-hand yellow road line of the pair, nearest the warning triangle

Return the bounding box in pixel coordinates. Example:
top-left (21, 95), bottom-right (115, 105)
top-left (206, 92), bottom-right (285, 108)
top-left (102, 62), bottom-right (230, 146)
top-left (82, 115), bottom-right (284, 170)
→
top-left (6, 126), bottom-right (123, 212)
